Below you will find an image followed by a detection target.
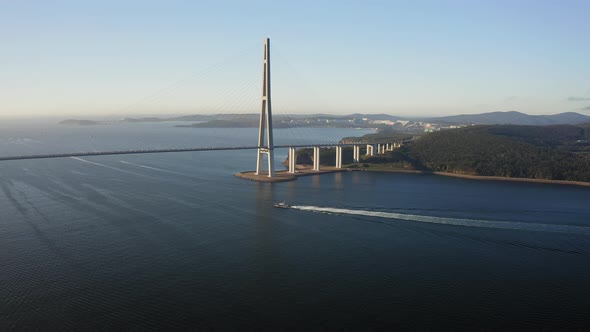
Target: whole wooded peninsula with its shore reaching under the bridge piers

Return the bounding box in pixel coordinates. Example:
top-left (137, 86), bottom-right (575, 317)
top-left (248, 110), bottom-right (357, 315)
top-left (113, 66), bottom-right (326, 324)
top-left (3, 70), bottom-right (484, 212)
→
top-left (297, 124), bottom-right (590, 185)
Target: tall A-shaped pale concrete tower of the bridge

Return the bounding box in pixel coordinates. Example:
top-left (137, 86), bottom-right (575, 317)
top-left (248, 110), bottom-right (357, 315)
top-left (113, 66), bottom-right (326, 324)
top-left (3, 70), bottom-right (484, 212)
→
top-left (256, 38), bottom-right (274, 177)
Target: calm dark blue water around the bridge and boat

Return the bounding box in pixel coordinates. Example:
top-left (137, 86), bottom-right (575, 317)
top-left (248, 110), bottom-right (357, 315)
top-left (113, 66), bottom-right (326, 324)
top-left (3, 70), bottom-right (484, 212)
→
top-left (0, 122), bottom-right (590, 330)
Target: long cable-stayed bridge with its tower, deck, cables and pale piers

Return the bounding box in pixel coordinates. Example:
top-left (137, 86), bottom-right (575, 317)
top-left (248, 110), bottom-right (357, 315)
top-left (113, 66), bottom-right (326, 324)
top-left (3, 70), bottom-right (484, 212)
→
top-left (0, 38), bottom-right (408, 177)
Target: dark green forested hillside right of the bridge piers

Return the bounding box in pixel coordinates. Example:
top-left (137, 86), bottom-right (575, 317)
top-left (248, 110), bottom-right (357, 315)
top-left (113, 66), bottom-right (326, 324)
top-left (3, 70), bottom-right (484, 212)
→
top-left (394, 126), bottom-right (590, 181)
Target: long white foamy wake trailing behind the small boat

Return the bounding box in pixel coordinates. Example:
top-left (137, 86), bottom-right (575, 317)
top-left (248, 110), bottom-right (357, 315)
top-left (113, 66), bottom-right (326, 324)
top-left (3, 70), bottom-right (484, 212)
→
top-left (291, 205), bottom-right (590, 236)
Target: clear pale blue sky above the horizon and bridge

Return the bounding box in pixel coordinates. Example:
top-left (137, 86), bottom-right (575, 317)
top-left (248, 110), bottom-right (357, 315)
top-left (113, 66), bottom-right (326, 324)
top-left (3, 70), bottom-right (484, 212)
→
top-left (0, 0), bottom-right (590, 116)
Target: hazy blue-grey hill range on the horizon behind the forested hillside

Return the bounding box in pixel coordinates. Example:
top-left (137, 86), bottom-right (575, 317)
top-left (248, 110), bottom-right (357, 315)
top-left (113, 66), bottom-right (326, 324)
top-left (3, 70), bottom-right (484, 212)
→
top-left (428, 111), bottom-right (590, 126)
